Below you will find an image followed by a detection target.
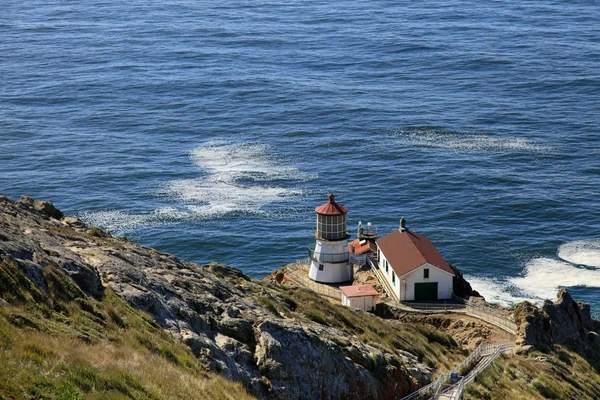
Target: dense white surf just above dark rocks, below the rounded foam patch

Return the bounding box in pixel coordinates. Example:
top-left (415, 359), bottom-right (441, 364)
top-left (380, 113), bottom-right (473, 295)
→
top-left (509, 258), bottom-right (600, 300)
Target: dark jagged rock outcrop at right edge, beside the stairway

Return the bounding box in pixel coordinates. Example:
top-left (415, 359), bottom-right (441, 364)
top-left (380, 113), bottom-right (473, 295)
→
top-left (515, 289), bottom-right (600, 353)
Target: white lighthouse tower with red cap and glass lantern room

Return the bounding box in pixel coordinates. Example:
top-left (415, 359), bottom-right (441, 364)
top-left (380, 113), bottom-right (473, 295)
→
top-left (308, 193), bottom-right (354, 283)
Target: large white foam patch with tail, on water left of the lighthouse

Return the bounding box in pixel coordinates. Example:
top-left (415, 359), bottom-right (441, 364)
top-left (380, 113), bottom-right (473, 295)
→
top-left (80, 141), bottom-right (315, 232)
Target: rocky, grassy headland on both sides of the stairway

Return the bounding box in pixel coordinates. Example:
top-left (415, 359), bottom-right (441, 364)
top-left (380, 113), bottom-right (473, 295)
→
top-left (0, 192), bottom-right (600, 400)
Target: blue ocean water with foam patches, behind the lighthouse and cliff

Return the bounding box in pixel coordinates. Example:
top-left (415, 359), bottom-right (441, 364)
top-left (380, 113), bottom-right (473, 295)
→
top-left (0, 0), bottom-right (600, 315)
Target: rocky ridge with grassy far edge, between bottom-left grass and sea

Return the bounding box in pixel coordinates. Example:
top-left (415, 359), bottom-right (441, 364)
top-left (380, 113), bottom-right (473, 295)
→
top-left (0, 197), bottom-right (462, 399)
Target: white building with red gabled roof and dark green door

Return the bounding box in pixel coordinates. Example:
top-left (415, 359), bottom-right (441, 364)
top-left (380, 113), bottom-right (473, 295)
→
top-left (376, 218), bottom-right (454, 301)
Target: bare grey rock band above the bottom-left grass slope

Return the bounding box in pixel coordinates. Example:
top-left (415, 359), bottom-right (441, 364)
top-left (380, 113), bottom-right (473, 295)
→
top-left (0, 197), bottom-right (424, 399)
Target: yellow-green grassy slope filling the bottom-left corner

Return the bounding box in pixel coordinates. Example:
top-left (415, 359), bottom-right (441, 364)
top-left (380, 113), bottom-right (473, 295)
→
top-left (0, 259), bottom-right (251, 400)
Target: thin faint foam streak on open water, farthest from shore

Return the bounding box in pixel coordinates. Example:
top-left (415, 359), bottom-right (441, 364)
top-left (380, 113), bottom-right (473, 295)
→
top-left (394, 129), bottom-right (553, 153)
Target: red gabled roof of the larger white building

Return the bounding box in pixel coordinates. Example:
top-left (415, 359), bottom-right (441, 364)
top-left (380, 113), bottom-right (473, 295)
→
top-left (376, 230), bottom-right (454, 276)
